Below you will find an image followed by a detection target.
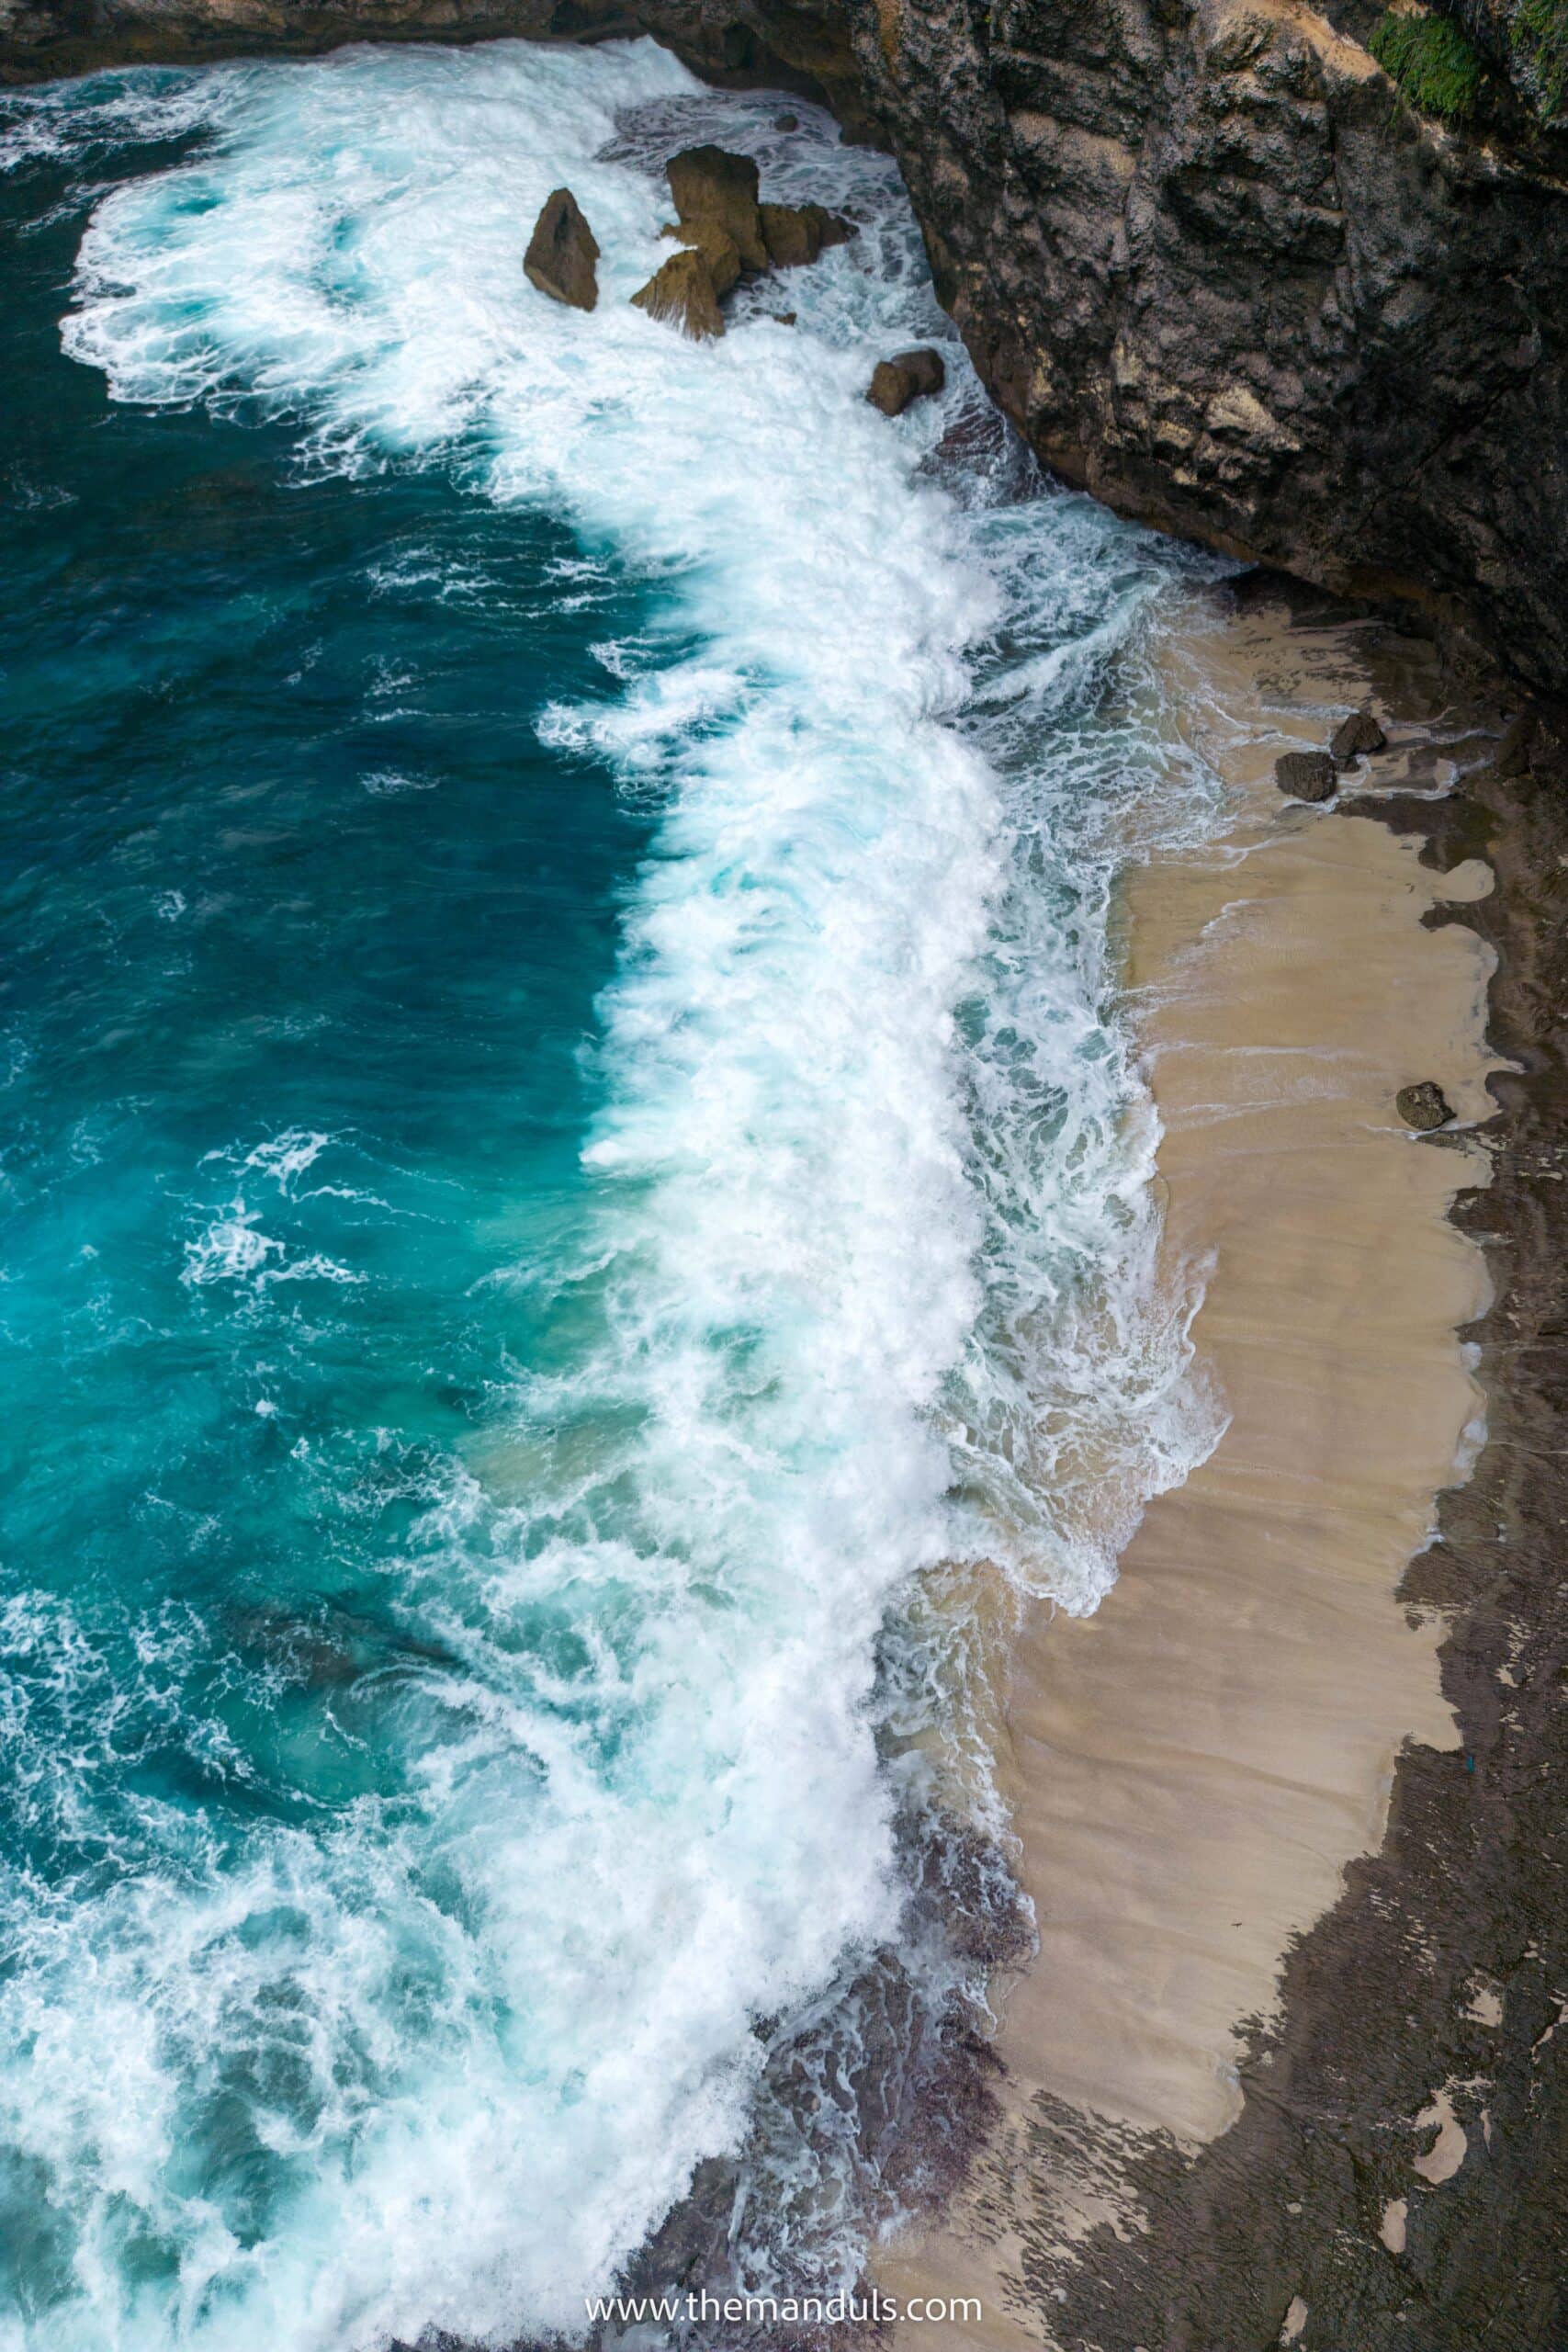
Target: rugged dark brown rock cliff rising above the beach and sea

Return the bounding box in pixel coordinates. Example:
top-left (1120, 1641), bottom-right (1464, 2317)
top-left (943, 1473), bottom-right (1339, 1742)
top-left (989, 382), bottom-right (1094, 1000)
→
top-left (0, 0), bottom-right (1568, 689)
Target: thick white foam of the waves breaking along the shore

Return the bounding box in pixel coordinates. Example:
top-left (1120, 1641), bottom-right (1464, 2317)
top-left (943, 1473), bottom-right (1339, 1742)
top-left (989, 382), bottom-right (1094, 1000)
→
top-left (0, 45), bottom-right (1203, 2352)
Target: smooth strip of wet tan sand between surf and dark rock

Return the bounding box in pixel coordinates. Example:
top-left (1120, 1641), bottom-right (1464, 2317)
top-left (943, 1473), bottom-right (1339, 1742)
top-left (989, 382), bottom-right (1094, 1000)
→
top-left (879, 582), bottom-right (1491, 2352)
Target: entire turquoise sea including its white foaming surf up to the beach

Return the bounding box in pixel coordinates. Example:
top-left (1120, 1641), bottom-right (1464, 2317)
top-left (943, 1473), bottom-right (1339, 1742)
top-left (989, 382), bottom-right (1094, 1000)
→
top-left (0, 45), bottom-right (1211, 2352)
